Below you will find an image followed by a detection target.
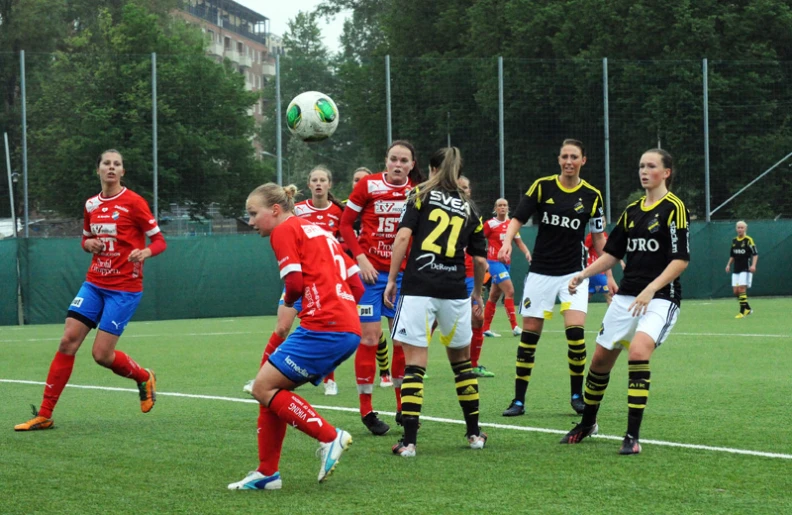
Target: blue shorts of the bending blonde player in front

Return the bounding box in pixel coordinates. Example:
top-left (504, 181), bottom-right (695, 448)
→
top-left (269, 326), bottom-right (360, 385)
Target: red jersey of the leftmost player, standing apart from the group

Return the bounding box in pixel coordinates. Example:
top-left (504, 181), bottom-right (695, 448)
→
top-left (83, 188), bottom-right (164, 292)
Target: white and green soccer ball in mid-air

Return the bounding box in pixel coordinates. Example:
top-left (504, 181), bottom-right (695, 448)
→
top-left (286, 91), bottom-right (338, 141)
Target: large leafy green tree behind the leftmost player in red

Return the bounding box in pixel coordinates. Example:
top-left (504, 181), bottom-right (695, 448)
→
top-left (29, 2), bottom-right (266, 215)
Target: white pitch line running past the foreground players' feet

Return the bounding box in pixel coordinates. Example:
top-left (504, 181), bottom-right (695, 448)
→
top-left (6, 379), bottom-right (792, 460)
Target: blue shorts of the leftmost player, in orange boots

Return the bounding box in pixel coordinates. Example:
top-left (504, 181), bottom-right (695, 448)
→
top-left (67, 282), bottom-right (143, 336)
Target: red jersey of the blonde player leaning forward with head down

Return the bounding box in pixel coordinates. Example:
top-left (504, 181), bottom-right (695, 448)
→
top-left (270, 216), bottom-right (361, 335)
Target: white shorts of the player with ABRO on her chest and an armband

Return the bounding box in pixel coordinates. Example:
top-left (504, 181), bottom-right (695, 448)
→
top-left (520, 272), bottom-right (588, 320)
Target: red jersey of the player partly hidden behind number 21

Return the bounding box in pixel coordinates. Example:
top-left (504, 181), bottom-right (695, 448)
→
top-left (347, 172), bottom-right (413, 272)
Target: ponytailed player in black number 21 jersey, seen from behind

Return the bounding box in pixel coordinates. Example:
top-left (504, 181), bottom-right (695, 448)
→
top-left (385, 147), bottom-right (487, 458)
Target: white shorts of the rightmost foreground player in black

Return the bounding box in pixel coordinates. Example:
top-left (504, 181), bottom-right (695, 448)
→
top-left (597, 295), bottom-right (679, 350)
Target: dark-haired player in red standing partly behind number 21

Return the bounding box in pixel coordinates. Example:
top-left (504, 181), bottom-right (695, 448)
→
top-left (341, 140), bottom-right (421, 435)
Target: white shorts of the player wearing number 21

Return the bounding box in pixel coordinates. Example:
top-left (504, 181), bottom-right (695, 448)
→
top-left (392, 295), bottom-right (473, 349)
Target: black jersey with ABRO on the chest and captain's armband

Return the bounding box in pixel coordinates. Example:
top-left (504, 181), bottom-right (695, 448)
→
top-left (514, 175), bottom-right (605, 276)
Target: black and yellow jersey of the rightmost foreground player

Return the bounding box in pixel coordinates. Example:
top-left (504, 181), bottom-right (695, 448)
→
top-left (605, 192), bottom-right (690, 304)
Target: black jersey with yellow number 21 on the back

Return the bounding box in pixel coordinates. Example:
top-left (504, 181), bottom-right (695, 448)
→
top-left (399, 188), bottom-right (487, 299)
